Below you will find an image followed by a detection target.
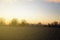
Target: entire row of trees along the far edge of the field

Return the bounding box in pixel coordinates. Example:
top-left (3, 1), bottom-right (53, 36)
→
top-left (0, 18), bottom-right (60, 28)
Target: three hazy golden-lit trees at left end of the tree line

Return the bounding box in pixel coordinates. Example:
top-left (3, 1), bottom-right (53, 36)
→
top-left (0, 18), bottom-right (27, 26)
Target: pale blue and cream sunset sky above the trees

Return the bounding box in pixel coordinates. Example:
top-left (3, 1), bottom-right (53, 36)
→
top-left (0, 0), bottom-right (60, 23)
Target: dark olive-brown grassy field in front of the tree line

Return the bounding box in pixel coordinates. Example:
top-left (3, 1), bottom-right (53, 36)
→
top-left (0, 26), bottom-right (60, 40)
